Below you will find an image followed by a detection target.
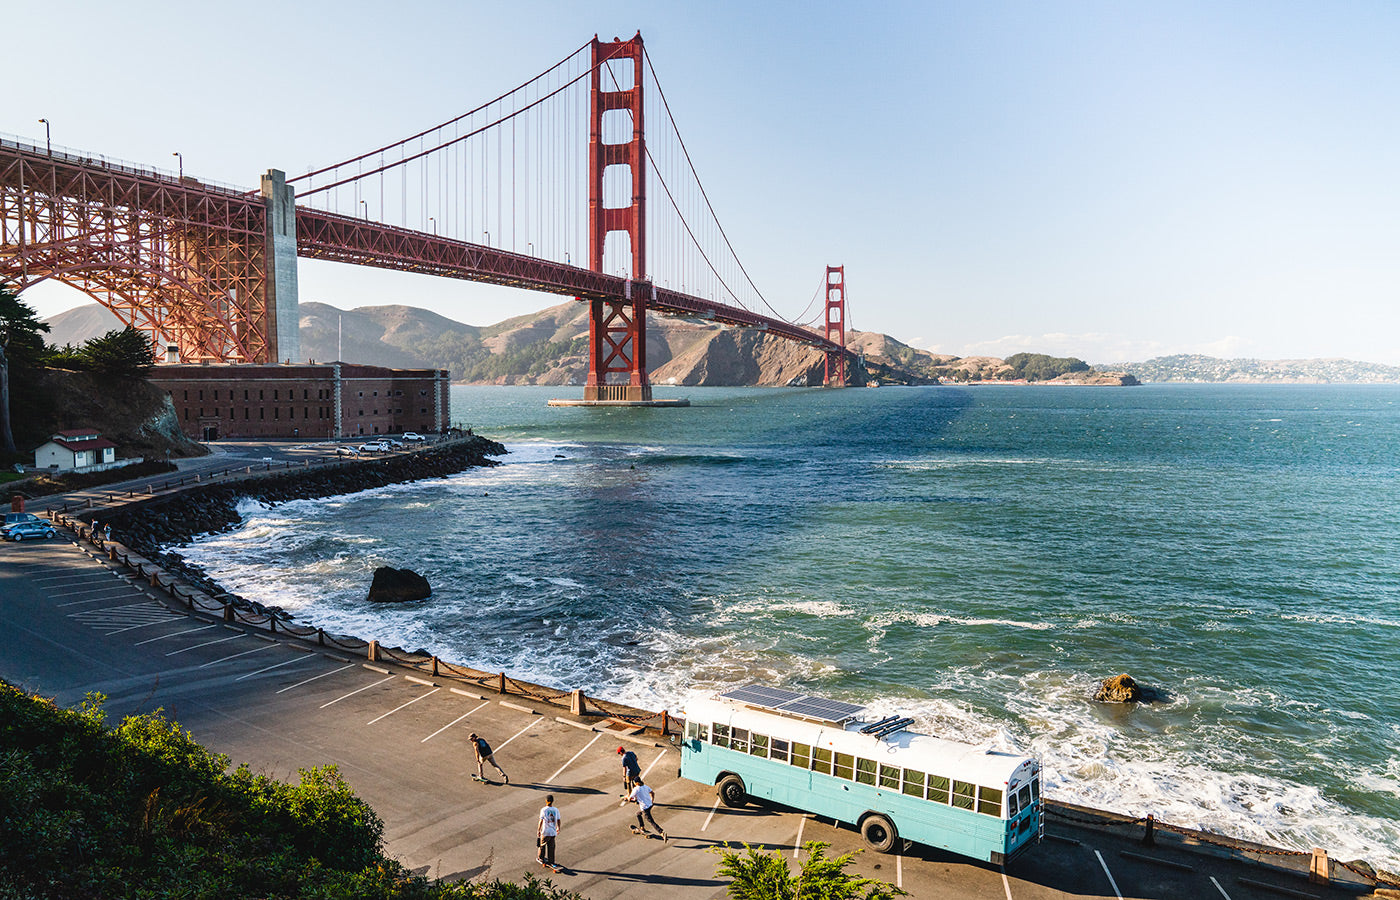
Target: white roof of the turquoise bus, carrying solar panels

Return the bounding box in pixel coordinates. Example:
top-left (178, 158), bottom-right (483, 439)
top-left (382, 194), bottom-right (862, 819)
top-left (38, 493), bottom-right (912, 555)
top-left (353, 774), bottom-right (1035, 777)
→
top-left (686, 697), bottom-right (1033, 787)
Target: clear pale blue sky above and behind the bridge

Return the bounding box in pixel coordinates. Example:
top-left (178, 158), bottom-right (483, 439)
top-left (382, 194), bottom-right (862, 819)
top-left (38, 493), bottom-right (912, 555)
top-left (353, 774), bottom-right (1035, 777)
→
top-left (10, 0), bottom-right (1400, 365)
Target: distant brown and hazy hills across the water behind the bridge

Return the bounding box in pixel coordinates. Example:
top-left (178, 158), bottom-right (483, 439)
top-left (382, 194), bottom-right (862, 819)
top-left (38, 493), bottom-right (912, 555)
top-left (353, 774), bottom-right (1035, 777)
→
top-left (46, 301), bottom-right (1400, 386)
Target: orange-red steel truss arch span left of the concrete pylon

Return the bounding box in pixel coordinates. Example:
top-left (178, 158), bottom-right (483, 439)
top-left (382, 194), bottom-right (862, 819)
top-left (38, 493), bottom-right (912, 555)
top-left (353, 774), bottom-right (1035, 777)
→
top-left (0, 141), bottom-right (277, 363)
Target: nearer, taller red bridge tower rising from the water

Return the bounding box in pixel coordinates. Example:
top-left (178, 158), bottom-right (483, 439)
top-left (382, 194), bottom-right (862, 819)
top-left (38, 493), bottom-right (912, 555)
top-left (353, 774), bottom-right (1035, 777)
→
top-left (584, 31), bottom-right (651, 402)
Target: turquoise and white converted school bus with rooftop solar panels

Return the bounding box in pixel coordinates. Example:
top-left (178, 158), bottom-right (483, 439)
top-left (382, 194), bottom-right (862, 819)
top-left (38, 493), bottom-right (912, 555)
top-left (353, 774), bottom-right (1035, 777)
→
top-left (680, 684), bottom-right (1044, 865)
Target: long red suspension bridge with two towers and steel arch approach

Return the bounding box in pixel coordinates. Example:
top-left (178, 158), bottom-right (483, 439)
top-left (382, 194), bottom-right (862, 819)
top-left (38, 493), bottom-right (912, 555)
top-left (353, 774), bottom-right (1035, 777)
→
top-left (0, 34), bottom-right (847, 402)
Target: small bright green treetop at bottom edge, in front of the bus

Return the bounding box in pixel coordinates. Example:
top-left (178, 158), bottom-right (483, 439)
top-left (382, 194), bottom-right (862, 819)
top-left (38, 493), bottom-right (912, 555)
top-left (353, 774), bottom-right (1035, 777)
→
top-left (711, 841), bottom-right (909, 900)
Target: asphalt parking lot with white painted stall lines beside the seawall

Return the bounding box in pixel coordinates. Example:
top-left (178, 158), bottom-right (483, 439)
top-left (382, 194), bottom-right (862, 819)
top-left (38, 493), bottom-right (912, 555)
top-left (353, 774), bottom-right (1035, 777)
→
top-left (0, 530), bottom-right (1371, 900)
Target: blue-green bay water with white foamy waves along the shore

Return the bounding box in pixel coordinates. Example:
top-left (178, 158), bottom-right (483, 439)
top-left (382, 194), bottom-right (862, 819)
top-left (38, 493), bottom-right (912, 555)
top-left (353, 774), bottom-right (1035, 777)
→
top-left (182, 385), bottom-right (1400, 869)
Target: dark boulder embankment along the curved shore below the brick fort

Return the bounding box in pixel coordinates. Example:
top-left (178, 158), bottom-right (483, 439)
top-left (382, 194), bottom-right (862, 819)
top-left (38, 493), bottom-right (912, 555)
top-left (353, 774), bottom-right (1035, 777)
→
top-left (102, 435), bottom-right (507, 619)
